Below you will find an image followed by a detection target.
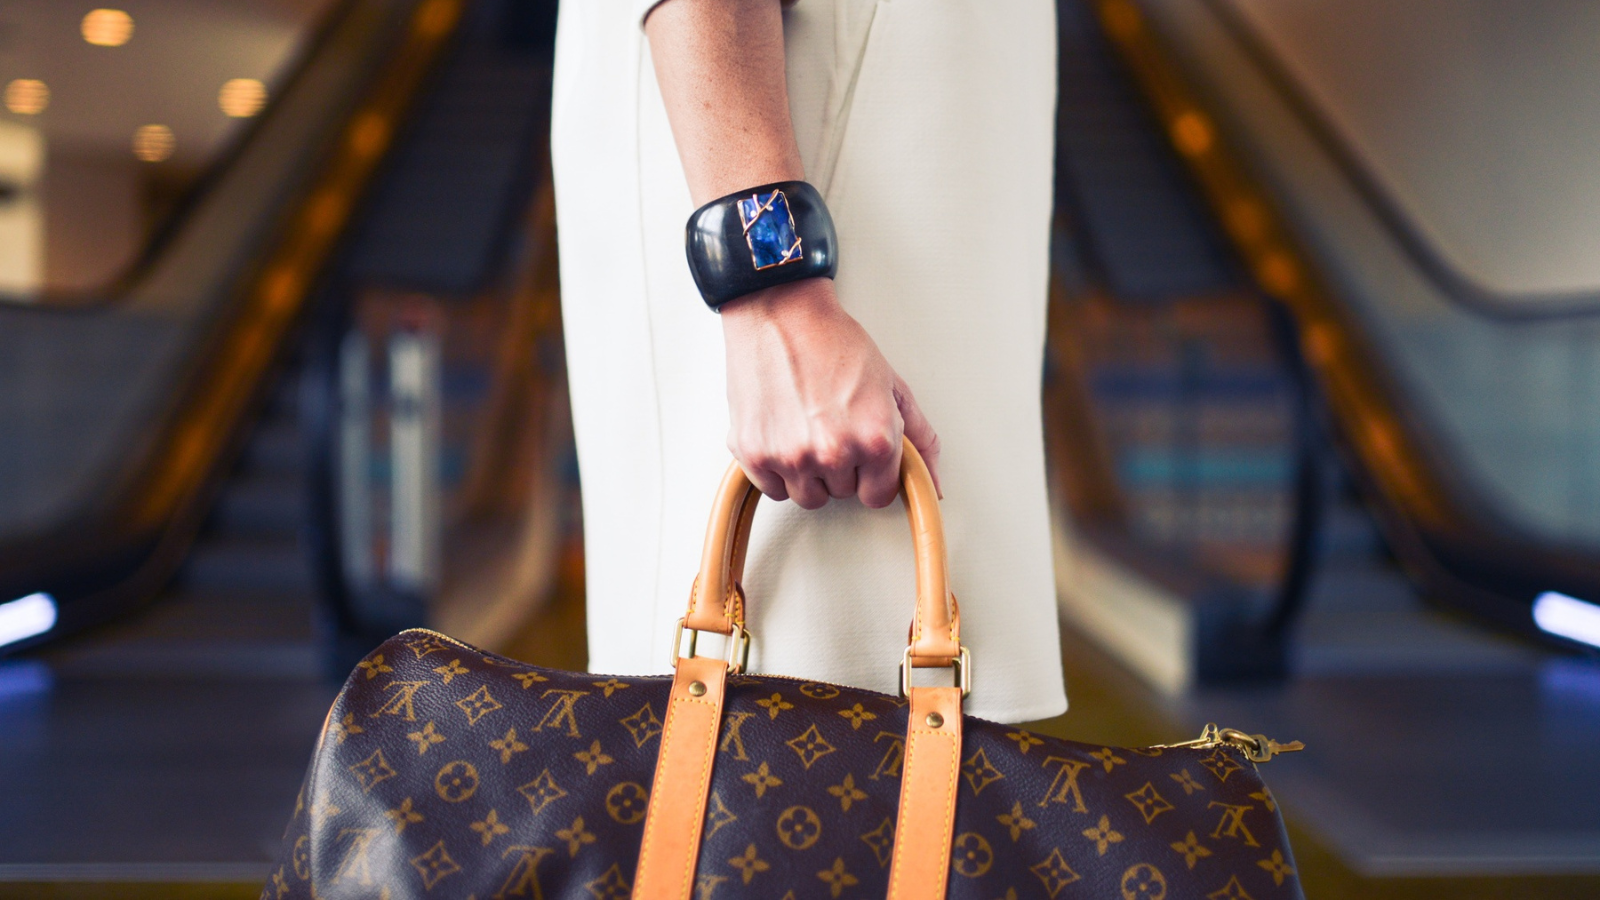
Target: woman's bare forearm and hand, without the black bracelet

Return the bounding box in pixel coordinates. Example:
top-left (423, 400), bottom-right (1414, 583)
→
top-left (645, 0), bottom-right (939, 509)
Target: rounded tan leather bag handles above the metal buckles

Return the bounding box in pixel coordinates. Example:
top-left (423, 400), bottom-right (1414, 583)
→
top-left (683, 440), bottom-right (962, 666)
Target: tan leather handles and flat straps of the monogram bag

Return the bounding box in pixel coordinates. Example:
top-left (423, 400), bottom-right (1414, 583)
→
top-left (632, 440), bottom-right (971, 900)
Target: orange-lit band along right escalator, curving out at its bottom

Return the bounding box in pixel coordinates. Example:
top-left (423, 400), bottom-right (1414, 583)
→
top-left (1096, 0), bottom-right (1600, 631)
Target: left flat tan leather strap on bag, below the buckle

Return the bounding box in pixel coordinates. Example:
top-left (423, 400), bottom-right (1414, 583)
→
top-left (634, 657), bottom-right (728, 900)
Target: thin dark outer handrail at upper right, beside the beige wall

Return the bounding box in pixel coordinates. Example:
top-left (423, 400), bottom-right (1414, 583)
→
top-left (1202, 0), bottom-right (1600, 322)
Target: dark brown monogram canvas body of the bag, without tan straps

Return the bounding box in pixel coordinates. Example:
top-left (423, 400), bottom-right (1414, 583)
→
top-left (262, 631), bottom-right (1301, 900)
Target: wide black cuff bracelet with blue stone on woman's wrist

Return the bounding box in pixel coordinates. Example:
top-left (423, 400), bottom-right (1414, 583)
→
top-left (685, 181), bottom-right (838, 309)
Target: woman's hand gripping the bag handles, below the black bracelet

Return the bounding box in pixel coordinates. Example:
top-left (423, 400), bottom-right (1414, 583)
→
top-left (722, 279), bottom-right (939, 509)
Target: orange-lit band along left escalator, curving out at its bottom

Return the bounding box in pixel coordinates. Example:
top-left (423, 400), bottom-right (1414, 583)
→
top-left (0, 0), bottom-right (467, 653)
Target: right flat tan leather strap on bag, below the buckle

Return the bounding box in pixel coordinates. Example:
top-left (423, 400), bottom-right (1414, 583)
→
top-left (888, 687), bottom-right (962, 900)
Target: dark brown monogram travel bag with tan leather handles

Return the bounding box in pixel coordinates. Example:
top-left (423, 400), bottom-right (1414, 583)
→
top-left (262, 444), bottom-right (1301, 900)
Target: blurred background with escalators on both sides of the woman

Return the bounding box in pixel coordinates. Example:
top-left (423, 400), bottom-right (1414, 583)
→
top-left (0, 0), bottom-right (1600, 898)
